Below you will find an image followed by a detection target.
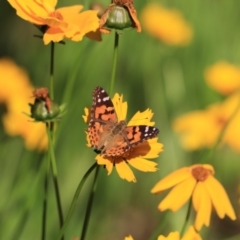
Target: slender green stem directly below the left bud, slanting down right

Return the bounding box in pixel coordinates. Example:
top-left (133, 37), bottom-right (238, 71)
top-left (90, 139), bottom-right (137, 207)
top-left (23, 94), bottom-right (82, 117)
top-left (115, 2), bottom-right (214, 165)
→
top-left (47, 123), bottom-right (64, 240)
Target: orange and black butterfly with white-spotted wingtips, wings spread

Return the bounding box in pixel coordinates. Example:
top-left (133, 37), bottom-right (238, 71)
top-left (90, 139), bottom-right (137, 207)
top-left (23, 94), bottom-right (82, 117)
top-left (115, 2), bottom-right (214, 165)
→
top-left (87, 87), bottom-right (159, 157)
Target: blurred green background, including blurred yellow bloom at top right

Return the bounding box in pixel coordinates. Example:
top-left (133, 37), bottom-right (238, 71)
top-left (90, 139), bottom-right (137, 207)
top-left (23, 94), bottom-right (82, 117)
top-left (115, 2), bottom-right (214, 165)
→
top-left (0, 0), bottom-right (240, 240)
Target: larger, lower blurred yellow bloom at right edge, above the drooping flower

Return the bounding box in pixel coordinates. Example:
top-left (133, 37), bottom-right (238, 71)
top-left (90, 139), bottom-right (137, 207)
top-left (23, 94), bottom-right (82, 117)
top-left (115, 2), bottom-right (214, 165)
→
top-left (173, 93), bottom-right (240, 151)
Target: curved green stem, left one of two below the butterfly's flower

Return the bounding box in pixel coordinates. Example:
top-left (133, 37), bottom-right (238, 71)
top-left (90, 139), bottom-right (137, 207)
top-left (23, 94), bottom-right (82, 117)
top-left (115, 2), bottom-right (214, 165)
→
top-left (57, 162), bottom-right (97, 240)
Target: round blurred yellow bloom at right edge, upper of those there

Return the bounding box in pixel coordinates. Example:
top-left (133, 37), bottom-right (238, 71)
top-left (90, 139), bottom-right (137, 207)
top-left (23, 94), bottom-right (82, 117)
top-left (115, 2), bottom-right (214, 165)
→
top-left (205, 61), bottom-right (240, 95)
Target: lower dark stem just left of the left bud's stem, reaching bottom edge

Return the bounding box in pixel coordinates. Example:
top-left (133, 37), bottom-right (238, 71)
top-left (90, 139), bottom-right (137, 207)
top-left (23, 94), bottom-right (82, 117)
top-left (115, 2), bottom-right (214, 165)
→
top-left (41, 149), bottom-right (50, 240)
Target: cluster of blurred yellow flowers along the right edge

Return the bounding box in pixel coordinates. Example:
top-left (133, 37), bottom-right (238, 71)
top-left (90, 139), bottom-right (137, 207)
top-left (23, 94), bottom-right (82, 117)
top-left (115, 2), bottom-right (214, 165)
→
top-left (173, 62), bottom-right (240, 151)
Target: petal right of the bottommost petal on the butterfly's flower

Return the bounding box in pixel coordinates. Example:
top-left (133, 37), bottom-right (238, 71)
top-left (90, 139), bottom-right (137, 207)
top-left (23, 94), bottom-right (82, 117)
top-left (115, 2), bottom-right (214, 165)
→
top-left (128, 158), bottom-right (157, 172)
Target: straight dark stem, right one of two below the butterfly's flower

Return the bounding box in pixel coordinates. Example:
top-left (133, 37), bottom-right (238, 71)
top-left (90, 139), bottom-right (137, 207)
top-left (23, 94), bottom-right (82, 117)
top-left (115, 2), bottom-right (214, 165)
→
top-left (80, 165), bottom-right (99, 240)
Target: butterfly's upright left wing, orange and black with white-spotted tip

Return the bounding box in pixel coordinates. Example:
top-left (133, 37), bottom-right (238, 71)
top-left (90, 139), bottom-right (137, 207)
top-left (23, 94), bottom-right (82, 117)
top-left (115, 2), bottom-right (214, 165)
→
top-left (88, 87), bottom-right (118, 149)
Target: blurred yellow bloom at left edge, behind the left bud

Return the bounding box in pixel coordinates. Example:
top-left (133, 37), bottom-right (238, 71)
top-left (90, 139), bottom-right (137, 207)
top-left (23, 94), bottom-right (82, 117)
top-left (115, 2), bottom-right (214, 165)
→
top-left (0, 59), bottom-right (48, 151)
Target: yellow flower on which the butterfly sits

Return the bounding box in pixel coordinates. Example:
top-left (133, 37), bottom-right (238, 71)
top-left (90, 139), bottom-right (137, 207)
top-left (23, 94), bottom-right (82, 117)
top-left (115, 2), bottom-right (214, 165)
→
top-left (83, 90), bottom-right (163, 182)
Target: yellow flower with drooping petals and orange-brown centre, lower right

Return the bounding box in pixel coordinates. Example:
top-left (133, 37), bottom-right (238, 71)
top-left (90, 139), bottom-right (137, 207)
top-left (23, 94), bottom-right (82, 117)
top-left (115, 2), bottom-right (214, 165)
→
top-left (151, 164), bottom-right (236, 231)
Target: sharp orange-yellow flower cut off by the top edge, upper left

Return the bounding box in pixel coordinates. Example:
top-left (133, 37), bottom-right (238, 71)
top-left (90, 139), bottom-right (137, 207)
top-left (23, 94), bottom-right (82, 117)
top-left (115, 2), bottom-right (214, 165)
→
top-left (8, 0), bottom-right (99, 44)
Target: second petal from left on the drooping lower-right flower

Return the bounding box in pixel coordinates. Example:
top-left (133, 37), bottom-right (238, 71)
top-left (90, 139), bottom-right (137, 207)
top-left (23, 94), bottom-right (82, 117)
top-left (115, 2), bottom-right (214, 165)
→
top-left (158, 178), bottom-right (196, 212)
